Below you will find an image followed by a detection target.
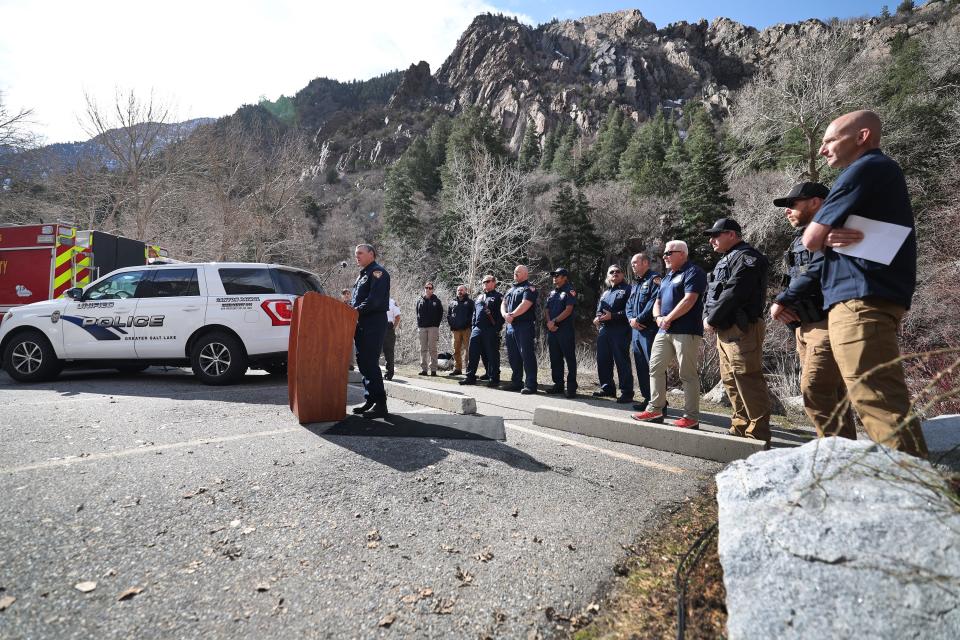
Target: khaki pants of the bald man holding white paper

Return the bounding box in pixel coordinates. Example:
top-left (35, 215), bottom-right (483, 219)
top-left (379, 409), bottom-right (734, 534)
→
top-left (828, 298), bottom-right (927, 457)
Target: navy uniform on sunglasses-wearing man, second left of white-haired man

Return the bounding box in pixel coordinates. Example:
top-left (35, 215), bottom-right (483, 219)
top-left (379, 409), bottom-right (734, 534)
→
top-left (597, 282), bottom-right (633, 400)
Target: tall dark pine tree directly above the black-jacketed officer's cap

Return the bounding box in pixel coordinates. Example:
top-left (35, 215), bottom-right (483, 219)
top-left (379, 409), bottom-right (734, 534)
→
top-left (677, 110), bottom-right (733, 264)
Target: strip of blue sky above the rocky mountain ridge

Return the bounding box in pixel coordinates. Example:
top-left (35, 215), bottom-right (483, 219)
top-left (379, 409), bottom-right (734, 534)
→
top-left (510, 0), bottom-right (900, 29)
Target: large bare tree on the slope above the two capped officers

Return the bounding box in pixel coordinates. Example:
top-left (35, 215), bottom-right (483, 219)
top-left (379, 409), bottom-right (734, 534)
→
top-left (729, 24), bottom-right (865, 181)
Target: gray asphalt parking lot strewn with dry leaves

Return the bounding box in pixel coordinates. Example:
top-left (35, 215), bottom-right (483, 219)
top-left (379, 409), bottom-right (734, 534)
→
top-left (0, 368), bottom-right (720, 638)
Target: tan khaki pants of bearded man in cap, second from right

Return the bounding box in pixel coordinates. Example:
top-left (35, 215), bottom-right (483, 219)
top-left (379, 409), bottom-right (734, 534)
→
top-left (796, 320), bottom-right (857, 440)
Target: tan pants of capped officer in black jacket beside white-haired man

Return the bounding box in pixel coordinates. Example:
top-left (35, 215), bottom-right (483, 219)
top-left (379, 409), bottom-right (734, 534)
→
top-left (717, 320), bottom-right (770, 442)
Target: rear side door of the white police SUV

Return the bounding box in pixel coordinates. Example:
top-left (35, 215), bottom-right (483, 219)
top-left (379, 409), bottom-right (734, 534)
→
top-left (134, 267), bottom-right (207, 360)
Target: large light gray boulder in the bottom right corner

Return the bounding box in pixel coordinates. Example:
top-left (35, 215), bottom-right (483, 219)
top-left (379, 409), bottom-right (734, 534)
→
top-left (717, 438), bottom-right (960, 640)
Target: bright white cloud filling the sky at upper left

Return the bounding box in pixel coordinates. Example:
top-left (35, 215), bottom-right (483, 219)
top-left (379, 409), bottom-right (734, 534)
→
top-left (0, 0), bottom-right (530, 142)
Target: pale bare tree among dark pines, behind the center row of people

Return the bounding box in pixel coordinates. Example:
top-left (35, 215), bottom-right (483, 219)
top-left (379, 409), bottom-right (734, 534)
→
top-left (449, 145), bottom-right (537, 283)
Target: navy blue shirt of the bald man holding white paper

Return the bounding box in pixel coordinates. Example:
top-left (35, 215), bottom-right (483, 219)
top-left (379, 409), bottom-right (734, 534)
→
top-left (813, 149), bottom-right (917, 309)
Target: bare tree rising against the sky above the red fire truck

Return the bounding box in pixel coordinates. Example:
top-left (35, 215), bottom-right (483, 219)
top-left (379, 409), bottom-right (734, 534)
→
top-left (82, 90), bottom-right (181, 240)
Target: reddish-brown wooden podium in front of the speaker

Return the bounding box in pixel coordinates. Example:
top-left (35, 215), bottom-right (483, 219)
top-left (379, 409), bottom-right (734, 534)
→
top-left (287, 291), bottom-right (357, 424)
